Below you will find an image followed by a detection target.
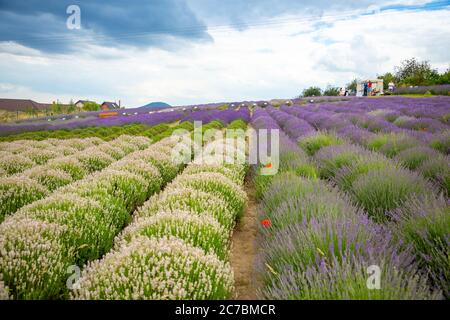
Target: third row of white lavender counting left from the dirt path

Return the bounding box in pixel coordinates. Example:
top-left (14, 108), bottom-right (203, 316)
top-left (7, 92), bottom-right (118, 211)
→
top-left (0, 135), bottom-right (151, 221)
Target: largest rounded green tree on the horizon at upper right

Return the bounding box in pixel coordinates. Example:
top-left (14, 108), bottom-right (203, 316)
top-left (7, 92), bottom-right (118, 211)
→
top-left (394, 58), bottom-right (439, 86)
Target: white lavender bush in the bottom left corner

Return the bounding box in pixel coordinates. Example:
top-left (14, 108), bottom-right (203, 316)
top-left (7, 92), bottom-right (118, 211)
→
top-left (0, 217), bottom-right (73, 299)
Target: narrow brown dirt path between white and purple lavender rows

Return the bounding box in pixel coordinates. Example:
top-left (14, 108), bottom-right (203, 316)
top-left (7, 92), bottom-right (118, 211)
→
top-left (230, 178), bottom-right (258, 300)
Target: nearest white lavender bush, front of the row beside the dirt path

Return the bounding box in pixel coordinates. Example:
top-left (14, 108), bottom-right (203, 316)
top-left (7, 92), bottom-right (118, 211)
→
top-left (72, 237), bottom-right (233, 300)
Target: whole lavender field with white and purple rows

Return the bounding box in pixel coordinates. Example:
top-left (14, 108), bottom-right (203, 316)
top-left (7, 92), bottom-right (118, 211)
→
top-left (0, 97), bottom-right (450, 300)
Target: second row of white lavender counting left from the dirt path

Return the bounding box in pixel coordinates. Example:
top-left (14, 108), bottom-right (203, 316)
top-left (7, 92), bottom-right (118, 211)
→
top-left (0, 134), bottom-right (191, 299)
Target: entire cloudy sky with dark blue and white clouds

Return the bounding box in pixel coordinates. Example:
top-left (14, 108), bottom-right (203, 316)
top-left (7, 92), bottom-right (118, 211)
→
top-left (0, 0), bottom-right (450, 107)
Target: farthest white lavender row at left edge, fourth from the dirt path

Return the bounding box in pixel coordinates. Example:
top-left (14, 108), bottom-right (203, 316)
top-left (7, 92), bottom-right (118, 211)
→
top-left (0, 137), bottom-right (105, 177)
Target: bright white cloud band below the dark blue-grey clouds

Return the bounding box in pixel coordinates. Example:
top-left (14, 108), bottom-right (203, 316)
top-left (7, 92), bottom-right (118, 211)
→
top-left (0, 6), bottom-right (450, 106)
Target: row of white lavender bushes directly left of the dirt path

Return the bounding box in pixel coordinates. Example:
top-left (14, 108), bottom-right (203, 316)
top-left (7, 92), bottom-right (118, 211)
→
top-left (71, 139), bottom-right (247, 300)
